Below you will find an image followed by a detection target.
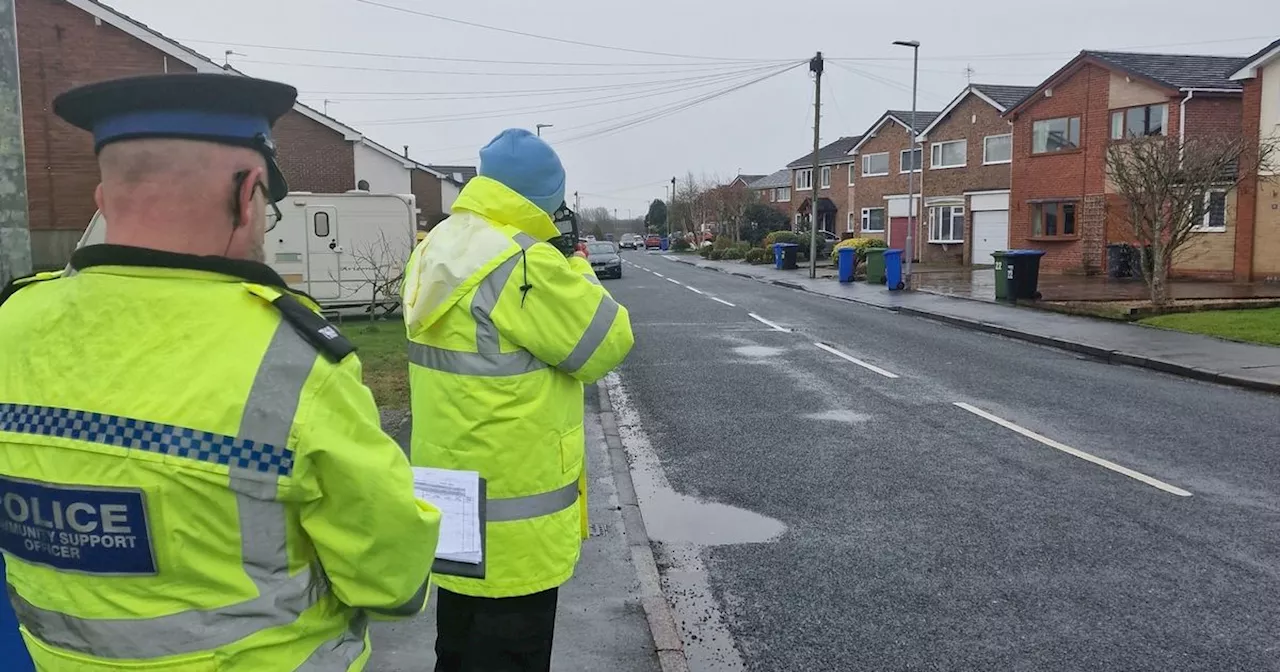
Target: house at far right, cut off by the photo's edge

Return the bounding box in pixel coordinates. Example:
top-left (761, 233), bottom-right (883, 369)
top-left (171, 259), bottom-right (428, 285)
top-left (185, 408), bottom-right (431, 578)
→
top-left (1231, 40), bottom-right (1280, 282)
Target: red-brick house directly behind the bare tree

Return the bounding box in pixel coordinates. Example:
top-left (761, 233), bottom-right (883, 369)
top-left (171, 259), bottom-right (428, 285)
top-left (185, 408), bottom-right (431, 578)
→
top-left (1005, 51), bottom-right (1242, 279)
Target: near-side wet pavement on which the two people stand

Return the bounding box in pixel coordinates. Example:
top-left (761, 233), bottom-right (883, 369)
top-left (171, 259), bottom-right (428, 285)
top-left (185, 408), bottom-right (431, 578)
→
top-left (369, 387), bottom-right (665, 672)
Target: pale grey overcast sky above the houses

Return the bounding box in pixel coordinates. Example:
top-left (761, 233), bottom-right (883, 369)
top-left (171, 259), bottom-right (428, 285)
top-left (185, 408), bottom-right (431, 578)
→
top-left (106, 0), bottom-right (1280, 216)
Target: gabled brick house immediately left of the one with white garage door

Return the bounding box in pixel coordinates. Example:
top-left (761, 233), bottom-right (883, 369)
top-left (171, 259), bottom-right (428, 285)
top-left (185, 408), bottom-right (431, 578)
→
top-left (846, 110), bottom-right (938, 259)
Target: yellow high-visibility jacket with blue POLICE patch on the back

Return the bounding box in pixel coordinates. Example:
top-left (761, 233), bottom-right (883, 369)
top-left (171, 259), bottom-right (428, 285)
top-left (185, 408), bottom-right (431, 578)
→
top-left (0, 246), bottom-right (439, 672)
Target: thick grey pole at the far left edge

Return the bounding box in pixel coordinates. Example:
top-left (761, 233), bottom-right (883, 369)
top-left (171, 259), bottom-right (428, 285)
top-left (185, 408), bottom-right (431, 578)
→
top-left (0, 0), bottom-right (31, 285)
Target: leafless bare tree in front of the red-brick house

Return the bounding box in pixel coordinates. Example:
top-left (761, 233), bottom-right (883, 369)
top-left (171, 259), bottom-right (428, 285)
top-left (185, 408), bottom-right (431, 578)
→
top-left (1107, 136), bottom-right (1276, 306)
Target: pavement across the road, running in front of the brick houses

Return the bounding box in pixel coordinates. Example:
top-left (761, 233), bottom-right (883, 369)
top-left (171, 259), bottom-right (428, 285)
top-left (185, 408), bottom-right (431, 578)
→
top-left (658, 255), bottom-right (1280, 392)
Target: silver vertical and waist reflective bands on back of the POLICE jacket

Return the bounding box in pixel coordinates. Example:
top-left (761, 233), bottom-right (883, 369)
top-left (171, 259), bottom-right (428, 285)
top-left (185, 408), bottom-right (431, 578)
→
top-left (9, 320), bottom-right (323, 659)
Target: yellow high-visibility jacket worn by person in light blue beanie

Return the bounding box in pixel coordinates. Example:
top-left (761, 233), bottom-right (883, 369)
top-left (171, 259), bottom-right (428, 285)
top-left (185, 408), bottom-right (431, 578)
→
top-left (403, 177), bottom-right (632, 598)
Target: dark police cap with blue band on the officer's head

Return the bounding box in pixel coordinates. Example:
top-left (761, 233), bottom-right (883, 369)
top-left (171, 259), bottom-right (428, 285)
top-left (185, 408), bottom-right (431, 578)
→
top-left (54, 73), bottom-right (298, 201)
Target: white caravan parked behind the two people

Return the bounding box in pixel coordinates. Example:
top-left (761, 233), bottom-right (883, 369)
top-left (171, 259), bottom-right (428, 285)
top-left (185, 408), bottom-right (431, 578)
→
top-left (77, 191), bottom-right (417, 312)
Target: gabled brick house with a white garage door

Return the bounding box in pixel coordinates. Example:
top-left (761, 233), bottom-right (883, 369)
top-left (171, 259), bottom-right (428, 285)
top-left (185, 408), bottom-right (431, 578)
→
top-left (915, 84), bottom-right (1034, 265)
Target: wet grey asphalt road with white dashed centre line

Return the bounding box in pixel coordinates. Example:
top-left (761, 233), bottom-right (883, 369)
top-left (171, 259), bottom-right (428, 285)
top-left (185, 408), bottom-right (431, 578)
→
top-left (607, 252), bottom-right (1280, 672)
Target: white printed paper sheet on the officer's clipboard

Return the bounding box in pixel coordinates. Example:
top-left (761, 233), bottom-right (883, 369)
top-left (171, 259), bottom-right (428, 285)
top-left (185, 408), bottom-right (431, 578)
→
top-left (413, 467), bottom-right (484, 564)
